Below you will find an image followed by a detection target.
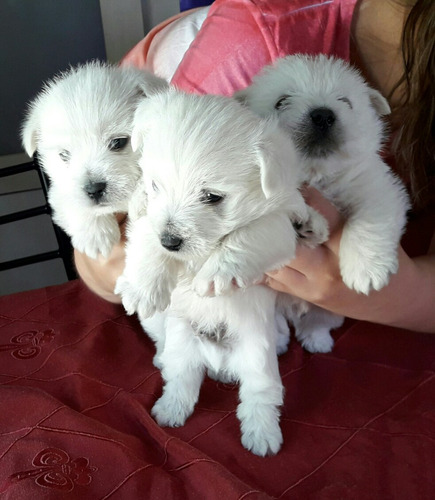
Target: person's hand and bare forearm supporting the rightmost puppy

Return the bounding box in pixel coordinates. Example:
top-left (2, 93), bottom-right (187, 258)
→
top-left (266, 190), bottom-right (435, 333)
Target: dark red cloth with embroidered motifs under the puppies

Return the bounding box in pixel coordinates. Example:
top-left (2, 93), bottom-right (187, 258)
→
top-left (0, 281), bottom-right (435, 500)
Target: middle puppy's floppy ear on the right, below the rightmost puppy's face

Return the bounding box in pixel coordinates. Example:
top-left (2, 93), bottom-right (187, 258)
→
top-left (259, 120), bottom-right (300, 198)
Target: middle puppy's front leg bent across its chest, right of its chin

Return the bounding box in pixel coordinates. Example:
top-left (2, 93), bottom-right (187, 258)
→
top-left (192, 213), bottom-right (296, 296)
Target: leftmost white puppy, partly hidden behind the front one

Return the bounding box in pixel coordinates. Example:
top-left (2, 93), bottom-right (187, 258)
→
top-left (22, 62), bottom-right (167, 258)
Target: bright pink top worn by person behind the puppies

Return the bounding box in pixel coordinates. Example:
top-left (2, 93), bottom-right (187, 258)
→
top-left (172, 0), bottom-right (357, 95)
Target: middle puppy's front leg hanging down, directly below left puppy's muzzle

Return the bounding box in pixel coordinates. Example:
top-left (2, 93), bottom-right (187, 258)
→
top-left (115, 217), bottom-right (178, 318)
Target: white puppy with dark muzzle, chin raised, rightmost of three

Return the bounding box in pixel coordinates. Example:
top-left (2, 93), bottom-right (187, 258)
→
top-left (236, 55), bottom-right (409, 294)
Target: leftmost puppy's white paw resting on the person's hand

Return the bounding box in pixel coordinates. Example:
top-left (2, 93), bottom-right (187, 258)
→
top-left (71, 216), bottom-right (121, 259)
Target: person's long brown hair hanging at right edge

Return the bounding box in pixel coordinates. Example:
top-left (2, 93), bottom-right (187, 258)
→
top-left (391, 0), bottom-right (435, 209)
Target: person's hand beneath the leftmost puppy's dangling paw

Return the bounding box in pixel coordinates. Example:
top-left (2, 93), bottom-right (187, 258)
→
top-left (74, 215), bottom-right (127, 304)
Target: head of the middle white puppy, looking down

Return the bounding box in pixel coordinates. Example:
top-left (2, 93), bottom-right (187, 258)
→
top-left (132, 90), bottom-right (302, 261)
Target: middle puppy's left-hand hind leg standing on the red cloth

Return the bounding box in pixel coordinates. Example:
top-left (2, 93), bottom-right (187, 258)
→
top-left (151, 316), bottom-right (204, 427)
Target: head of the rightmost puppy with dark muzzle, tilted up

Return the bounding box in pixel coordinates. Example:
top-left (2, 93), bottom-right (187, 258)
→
top-left (235, 55), bottom-right (390, 159)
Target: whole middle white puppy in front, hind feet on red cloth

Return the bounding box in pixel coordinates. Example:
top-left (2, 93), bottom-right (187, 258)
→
top-left (116, 90), bottom-right (328, 456)
